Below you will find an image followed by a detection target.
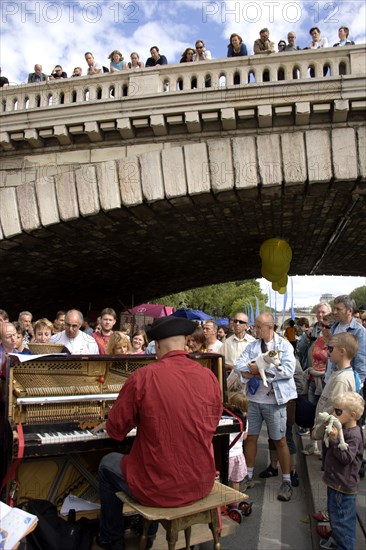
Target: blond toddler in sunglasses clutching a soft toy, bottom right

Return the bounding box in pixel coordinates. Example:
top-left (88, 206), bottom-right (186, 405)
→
top-left (320, 391), bottom-right (365, 550)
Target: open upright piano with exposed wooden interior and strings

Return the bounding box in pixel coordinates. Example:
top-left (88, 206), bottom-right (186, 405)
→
top-left (0, 353), bottom-right (240, 506)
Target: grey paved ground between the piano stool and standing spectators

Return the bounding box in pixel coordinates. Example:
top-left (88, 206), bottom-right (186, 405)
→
top-left (93, 429), bottom-right (366, 550)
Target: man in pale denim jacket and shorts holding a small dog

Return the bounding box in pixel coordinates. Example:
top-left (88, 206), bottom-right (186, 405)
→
top-left (235, 313), bottom-right (297, 502)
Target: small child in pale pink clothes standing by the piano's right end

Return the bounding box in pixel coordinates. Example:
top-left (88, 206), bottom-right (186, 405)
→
top-left (229, 392), bottom-right (248, 496)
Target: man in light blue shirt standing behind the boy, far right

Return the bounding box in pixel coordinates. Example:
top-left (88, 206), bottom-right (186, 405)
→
top-left (324, 294), bottom-right (366, 384)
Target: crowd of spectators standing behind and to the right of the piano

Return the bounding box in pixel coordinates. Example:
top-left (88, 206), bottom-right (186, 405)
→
top-left (0, 296), bottom-right (366, 548)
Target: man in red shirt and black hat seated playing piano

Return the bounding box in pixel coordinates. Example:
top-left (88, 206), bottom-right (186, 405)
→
top-left (95, 317), bottom-right (222, 550)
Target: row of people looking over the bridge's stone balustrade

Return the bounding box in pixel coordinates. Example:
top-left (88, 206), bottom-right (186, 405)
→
top-left (0, 26), bottom-right (355, 87)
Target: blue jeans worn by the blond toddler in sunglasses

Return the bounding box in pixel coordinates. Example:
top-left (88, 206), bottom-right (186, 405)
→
top-left (327, 487), bottom-right (356, 550)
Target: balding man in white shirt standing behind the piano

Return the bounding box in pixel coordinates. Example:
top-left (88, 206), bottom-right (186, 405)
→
top-left (50, 309), bottom-right (99, 355)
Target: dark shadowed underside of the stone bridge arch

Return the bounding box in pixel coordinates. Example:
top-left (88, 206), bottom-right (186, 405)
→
top-left (0, 181), bottom-right (366, 318)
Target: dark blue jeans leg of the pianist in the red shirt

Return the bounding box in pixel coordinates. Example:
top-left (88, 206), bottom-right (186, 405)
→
top-left (99, 453), bottom-right (131, 542)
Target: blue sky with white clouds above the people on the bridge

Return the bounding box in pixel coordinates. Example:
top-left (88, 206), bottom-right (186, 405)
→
top-left (0, 0), bottom-right (366, 83)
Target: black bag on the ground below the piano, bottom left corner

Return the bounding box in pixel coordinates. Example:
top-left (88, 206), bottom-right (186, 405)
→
top-left (19, 499), bottom-right (93, 550)
